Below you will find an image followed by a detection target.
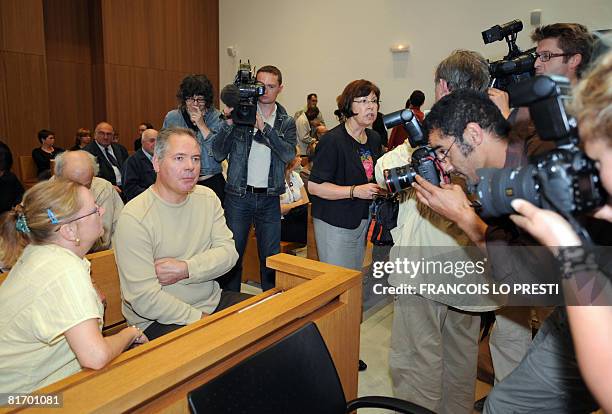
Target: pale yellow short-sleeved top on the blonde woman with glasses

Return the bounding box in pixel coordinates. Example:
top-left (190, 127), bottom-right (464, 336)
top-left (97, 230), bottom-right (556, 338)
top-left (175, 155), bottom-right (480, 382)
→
top-left (0, 244), bottom-right (104, 393)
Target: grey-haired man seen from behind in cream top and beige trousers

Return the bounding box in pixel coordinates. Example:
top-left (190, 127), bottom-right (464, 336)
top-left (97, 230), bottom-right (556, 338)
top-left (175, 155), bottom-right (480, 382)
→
top-left (376, 50), bottom-right (510, 414)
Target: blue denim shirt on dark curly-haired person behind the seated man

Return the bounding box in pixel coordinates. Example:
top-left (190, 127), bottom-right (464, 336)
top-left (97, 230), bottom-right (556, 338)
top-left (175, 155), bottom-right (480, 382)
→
top-left (163, 108), bottom-right (223, 175)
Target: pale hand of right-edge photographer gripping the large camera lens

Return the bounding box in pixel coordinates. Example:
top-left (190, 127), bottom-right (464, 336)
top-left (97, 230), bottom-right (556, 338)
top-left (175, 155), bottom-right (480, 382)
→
top-left (510, 199), bottom-right (582, 253)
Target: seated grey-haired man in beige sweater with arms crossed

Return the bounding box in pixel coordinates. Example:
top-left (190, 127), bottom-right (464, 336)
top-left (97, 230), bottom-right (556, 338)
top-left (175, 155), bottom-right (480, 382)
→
top-left (113, 128), bottom-right (240, 339)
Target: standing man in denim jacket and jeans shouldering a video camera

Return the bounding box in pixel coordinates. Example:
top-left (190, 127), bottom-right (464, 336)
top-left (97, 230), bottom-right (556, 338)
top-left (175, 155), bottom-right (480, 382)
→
top-left (212, 66), bottom-right (296, 292)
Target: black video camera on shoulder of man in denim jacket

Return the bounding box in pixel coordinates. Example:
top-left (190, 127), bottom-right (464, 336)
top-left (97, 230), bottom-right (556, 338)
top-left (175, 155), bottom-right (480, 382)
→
top-left (232, 62), bottom-right (266, 126)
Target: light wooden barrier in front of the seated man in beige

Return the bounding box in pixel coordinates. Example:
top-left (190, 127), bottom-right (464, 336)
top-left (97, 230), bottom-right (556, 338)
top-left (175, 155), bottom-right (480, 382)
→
top-left (5, 254), bottom-right (362, 413)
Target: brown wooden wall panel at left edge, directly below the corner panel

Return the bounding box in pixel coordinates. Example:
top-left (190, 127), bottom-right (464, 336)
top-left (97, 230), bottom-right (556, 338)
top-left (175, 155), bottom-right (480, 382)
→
top-left (0, 51), bottom-right (49, 180)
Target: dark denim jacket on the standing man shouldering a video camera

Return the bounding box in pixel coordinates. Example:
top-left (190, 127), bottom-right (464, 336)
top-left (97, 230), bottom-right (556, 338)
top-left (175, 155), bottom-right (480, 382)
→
top-left (211, 102), bottom-right (296, 196)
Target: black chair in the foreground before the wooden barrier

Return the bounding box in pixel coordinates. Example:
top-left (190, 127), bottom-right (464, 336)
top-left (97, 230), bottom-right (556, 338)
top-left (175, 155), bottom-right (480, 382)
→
top-left (187, 322), bottom-right (432, 414)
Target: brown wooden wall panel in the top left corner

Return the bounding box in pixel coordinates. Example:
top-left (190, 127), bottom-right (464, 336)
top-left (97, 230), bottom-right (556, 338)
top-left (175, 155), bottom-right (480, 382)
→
top-left (0, 0), bottom-right (45, 56)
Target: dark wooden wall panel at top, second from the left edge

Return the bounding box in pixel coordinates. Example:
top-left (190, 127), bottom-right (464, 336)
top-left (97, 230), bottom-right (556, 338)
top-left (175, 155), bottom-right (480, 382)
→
top-left (43, 0), bottom-right (91, 64)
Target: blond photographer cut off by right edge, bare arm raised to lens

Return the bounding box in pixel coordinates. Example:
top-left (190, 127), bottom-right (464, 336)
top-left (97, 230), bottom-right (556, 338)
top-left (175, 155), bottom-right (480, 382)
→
top-left (510, 53), bottom-right (612, 412)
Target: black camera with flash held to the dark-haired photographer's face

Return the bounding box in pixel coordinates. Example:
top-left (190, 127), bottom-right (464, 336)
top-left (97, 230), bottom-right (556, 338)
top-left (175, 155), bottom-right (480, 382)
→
top-left (383, 109), bottom-right (443, 193)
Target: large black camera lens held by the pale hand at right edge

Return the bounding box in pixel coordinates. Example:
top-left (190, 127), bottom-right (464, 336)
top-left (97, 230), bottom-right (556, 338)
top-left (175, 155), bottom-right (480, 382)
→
top-left (476, 165), bottom-right (541, 217)
